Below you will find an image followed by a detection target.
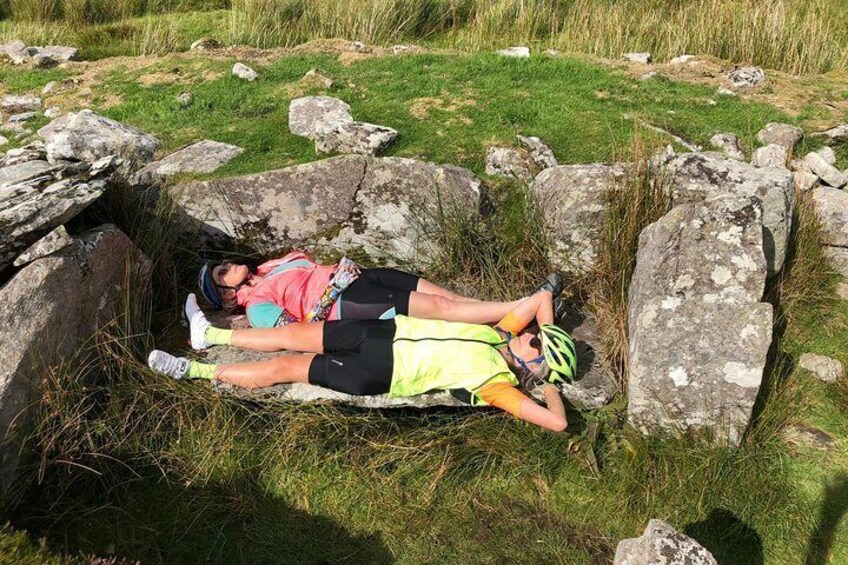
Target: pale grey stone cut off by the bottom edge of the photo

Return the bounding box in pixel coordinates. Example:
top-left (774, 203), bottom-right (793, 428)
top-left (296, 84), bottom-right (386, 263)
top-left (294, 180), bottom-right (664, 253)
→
top-left (613, 520), bottom-right (718, 565)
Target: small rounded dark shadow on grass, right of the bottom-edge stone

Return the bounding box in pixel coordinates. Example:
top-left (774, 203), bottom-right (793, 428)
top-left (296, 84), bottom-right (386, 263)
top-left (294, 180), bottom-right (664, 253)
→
top-left (683, 508), bottom-right (763, 565)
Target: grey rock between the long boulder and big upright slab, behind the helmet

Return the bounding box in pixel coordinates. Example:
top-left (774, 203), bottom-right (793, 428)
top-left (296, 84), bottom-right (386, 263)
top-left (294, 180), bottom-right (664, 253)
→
top-left (532, 164), bottom-right (628, 273)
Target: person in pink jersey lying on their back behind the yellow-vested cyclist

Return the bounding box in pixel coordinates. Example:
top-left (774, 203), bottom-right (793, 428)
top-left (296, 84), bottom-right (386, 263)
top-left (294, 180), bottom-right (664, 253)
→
top-left (198, 251), bottom-right (562, 328)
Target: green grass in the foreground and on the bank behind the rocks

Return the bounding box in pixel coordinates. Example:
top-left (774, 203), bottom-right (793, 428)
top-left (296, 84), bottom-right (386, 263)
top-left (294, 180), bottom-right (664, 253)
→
top-left (0, 50), bottom-right (848, 563)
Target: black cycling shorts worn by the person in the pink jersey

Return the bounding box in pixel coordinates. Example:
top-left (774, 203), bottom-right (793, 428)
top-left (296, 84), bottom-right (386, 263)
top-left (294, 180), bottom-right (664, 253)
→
top-left (338, 269), bottom-right (418, 320)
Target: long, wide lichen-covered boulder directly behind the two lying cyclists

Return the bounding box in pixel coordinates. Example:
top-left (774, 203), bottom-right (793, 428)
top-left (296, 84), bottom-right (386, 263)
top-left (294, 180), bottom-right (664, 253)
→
top-left (169, 156), bottom-right (481, 263)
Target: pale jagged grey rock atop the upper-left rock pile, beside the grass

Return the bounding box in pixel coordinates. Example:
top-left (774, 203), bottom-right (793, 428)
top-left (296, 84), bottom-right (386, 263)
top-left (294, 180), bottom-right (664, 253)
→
top-left (38, 110), bottom-right (159, 176)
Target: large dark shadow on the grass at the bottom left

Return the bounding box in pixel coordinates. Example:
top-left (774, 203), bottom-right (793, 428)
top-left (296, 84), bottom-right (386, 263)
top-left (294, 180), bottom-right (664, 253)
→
top-left (13, 470), bottom-right (394, 564)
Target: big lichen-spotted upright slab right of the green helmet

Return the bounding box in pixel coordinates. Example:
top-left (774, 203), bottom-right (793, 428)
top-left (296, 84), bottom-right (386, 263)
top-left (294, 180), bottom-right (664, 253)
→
top-left (628, 194), bottom-right (772, 445)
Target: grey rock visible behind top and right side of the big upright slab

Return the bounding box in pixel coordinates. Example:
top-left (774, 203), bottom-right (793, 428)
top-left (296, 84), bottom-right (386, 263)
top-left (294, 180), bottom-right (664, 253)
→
top-left (668, 153), bottom-right (795, 274)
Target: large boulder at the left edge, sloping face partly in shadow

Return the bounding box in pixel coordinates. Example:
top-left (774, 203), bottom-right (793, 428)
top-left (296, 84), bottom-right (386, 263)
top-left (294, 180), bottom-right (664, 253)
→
top-left (0, 225), bottom-right (146, 492)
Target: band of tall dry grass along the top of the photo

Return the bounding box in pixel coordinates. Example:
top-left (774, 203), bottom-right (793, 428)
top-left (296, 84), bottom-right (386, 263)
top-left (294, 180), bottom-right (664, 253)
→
top-left (0, 0), bottom-right (848, 74)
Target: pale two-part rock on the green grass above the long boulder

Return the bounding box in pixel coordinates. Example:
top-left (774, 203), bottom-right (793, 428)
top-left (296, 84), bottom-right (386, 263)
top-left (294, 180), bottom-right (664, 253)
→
top-left (289, 96), bottom-right (397, 155)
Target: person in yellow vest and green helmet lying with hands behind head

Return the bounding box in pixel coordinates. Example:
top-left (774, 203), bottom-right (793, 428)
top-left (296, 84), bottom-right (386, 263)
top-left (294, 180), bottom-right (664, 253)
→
top-left (148, 291), bottom-right (577, 432)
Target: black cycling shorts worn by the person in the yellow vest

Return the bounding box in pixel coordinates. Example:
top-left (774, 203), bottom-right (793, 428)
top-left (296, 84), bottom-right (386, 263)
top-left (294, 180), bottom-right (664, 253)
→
top-left (309, 320), bottom-right (395, 395)
